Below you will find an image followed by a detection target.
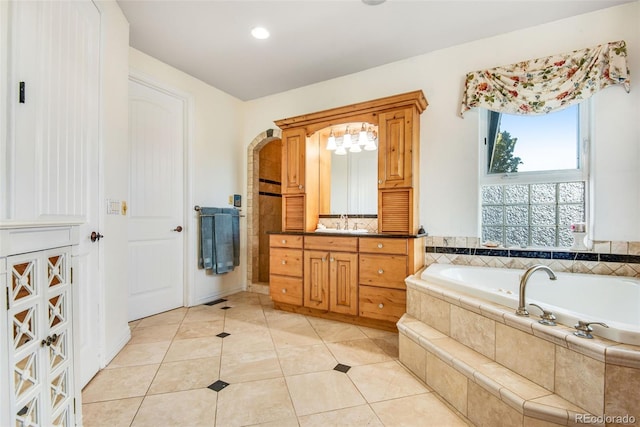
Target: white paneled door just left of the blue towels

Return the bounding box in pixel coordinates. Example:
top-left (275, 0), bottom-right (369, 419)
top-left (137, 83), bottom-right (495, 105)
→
top-left (128, 80), bottom-right (185, 320)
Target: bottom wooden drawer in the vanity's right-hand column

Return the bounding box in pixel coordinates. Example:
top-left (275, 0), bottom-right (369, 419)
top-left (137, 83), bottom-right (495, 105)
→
top-left (358, 286), bottom-right (407, 322)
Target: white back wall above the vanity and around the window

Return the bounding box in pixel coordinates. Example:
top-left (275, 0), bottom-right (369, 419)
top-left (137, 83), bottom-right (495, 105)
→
top-left (243, 2), bottom-right (640, 241)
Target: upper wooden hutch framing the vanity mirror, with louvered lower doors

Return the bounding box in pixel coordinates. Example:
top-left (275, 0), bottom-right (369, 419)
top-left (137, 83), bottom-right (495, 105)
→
top-left (275, 90), bottom-right (428, 234)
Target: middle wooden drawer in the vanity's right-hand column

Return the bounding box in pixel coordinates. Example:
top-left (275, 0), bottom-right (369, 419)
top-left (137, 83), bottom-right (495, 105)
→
top-left (359, 254), bottom-right (408, 289)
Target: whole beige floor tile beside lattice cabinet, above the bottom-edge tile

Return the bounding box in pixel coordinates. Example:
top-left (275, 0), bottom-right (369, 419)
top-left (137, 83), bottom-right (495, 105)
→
top-left (82, 365), bottom-right (159, 403)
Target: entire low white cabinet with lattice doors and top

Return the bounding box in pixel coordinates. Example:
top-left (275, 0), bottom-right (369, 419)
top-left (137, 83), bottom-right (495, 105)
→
top-left (0, 223), bottom-right (80, 427)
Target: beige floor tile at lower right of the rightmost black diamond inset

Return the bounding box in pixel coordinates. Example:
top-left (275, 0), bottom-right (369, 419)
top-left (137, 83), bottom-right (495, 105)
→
top-left (347, 361), bottom-right (429, 403)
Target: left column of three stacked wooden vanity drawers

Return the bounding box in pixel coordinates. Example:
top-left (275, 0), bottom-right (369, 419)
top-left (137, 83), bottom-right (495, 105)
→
top-left (269, 234), bottom-right (303, 305)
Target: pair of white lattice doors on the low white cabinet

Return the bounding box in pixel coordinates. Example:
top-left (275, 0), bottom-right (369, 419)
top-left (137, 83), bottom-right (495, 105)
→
top-left (6, 247), bottom-right (74, 427)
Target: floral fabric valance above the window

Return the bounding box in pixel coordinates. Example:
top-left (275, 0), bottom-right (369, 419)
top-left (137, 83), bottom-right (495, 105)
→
top-left (460, 40), bottom-right (630, 116)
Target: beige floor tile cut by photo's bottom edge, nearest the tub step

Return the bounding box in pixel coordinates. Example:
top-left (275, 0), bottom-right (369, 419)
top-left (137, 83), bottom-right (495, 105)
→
top-left (371, 393), bottom-right (467, 427)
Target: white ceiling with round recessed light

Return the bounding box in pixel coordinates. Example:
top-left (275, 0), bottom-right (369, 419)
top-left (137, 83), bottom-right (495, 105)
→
top-left (118, 0), bottom-right (635, 101)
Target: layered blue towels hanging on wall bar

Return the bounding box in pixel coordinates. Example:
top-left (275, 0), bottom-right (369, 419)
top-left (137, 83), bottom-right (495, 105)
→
top-left (198, 208), bottom-right (240, 274)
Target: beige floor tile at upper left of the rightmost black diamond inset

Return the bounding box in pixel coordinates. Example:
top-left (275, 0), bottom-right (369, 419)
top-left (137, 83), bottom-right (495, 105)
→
top-left (277, 344), bottom-right (338, 376)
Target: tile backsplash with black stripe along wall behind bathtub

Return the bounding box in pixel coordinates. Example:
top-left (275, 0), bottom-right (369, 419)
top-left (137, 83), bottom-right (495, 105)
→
top-left (425, 236), bottom-right (640, 277)
